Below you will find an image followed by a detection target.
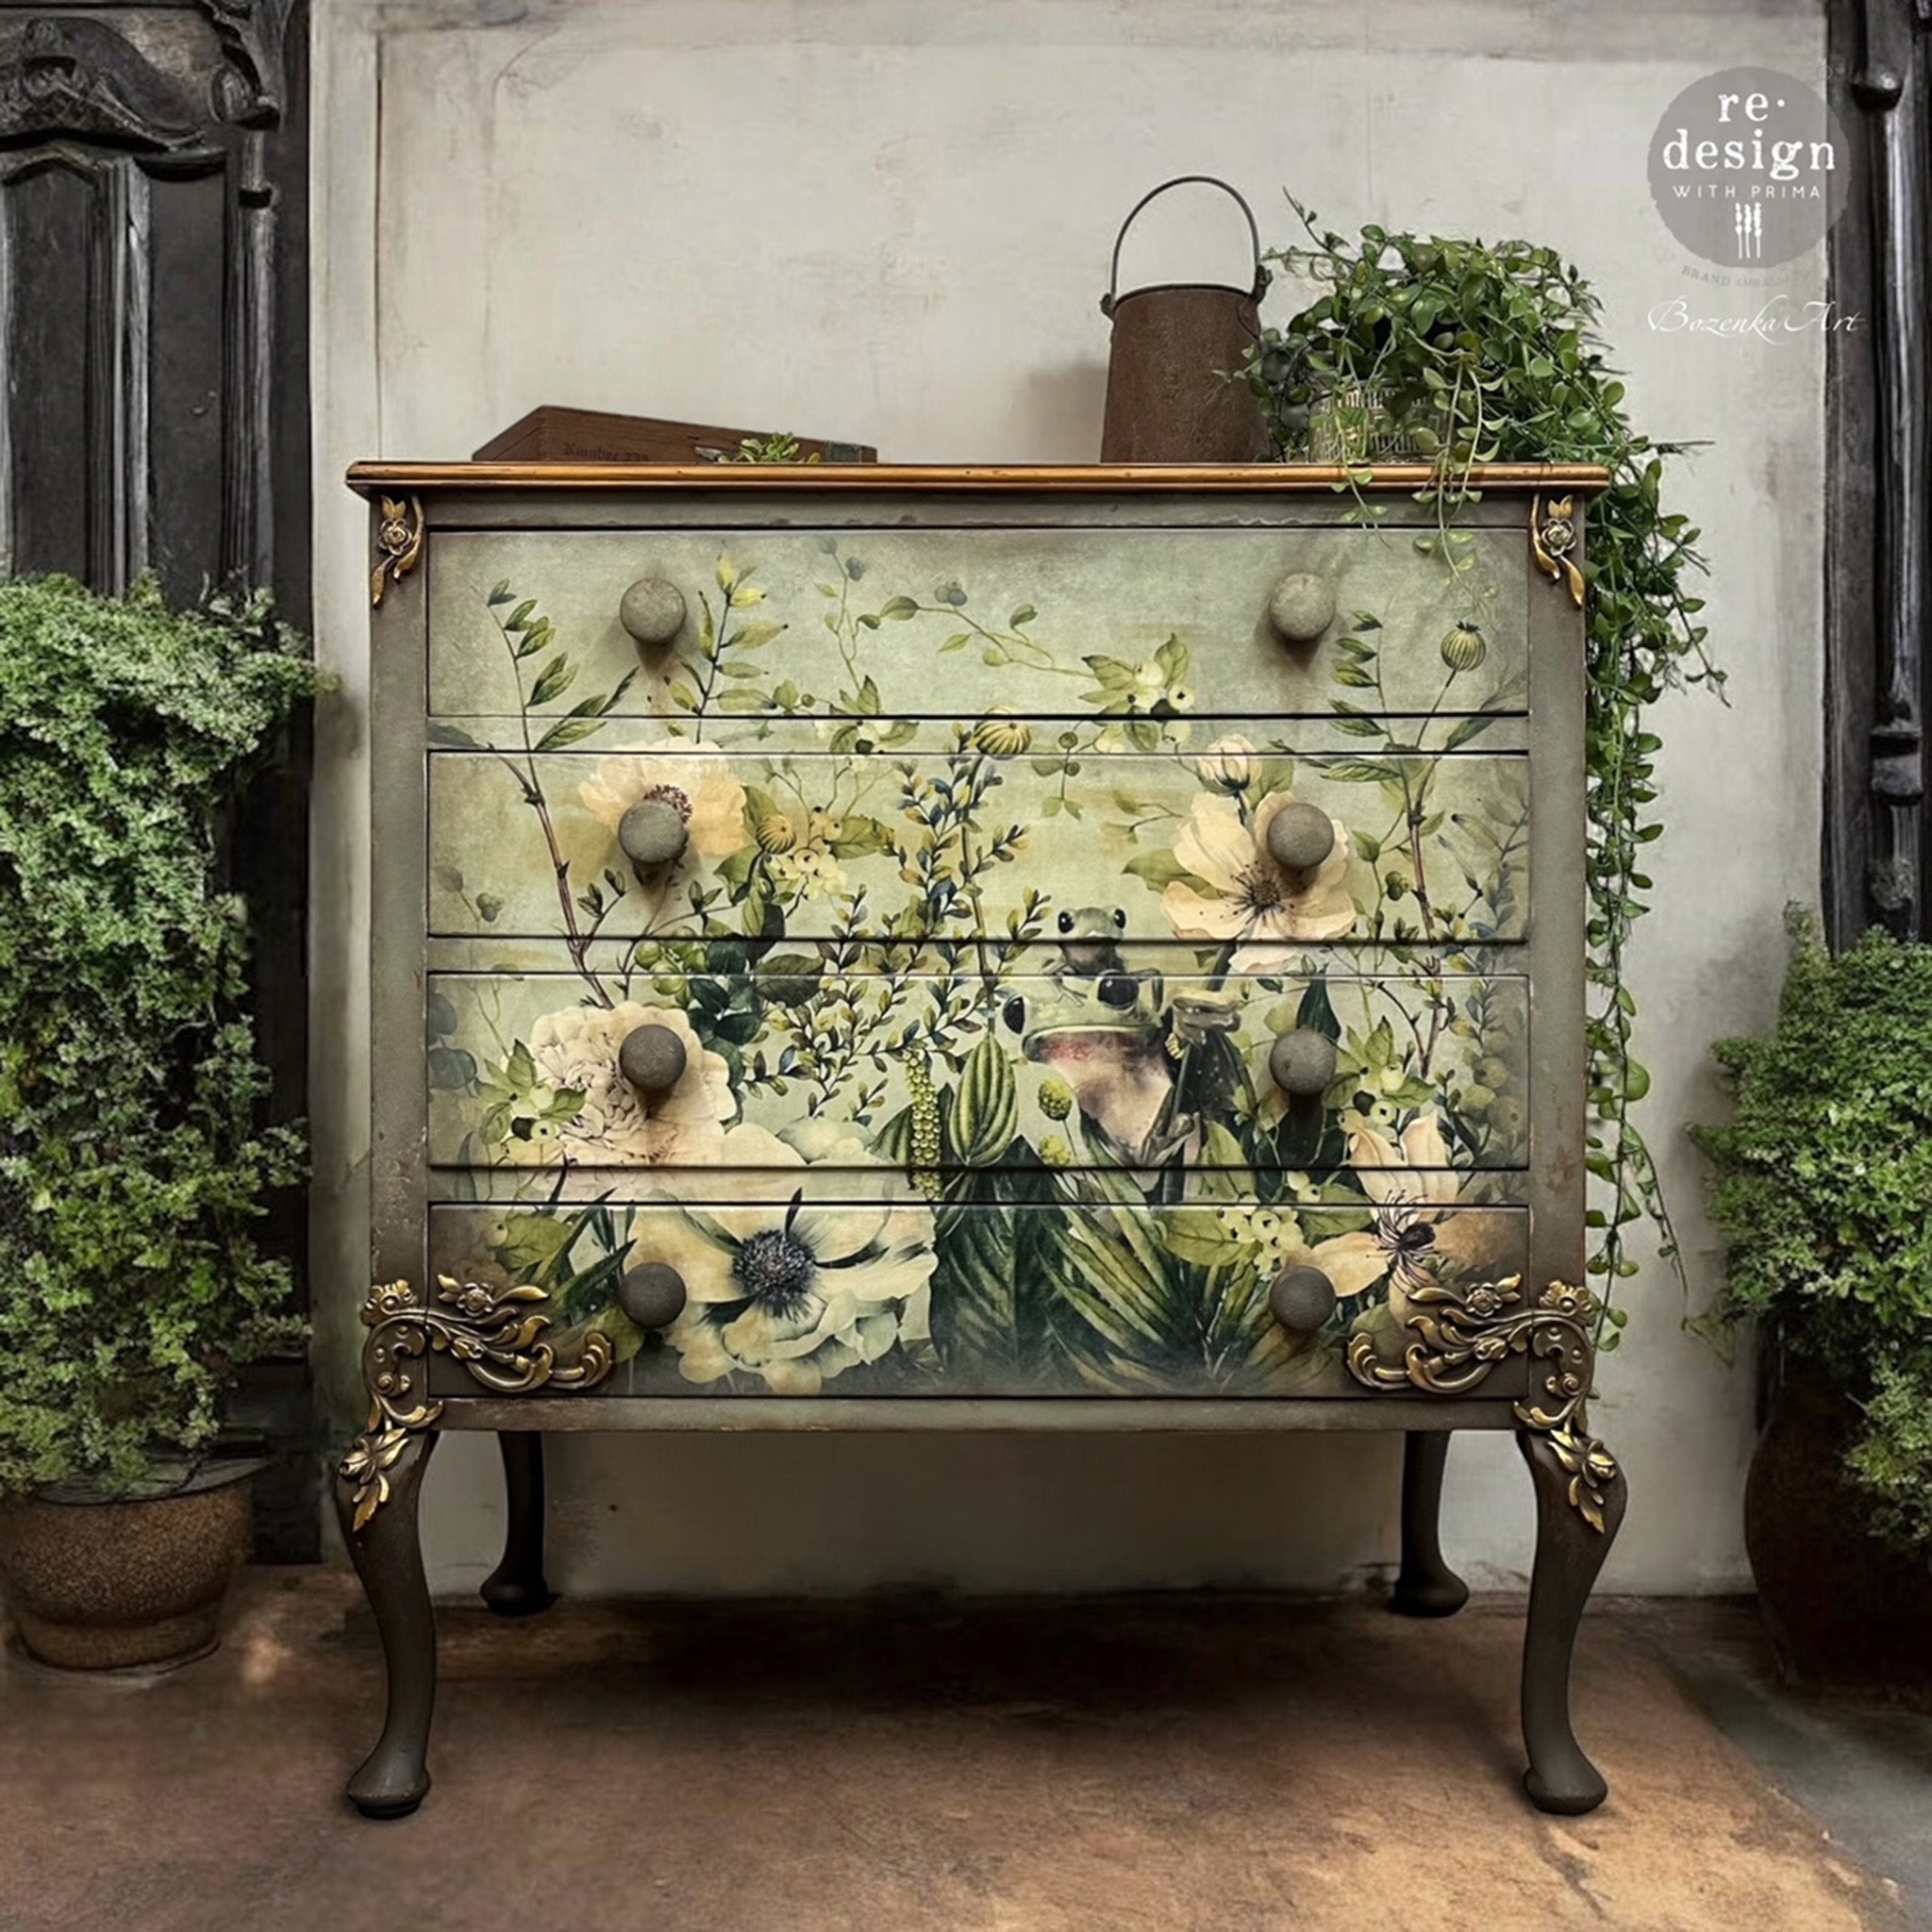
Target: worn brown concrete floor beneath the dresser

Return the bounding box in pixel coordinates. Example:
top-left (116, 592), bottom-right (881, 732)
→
top-left (0, 1571), bottom-right (1932, 1932)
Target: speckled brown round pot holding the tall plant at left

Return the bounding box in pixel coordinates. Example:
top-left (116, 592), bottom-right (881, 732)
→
top-left (0, 1462), bottom-right (260, 1672)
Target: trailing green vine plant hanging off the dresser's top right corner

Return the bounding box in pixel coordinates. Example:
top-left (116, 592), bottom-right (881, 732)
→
top-left (1241, 197), bottom-right (1724, 1346)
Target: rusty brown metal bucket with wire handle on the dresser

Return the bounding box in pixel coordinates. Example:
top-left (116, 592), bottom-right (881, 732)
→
top-left (1099, 174), bottom-right (1267, 464)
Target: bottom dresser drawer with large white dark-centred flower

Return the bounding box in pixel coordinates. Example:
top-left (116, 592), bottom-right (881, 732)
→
top-left (429, 1173), bottom-right (1530, 1397)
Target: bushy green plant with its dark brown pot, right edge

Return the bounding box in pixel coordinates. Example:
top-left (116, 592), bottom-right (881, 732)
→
top-left (1692, 914), bottom-right (1932, 1690)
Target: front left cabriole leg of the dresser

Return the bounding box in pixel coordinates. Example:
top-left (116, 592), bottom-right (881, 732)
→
top-left (336, 1430), bottom-right (437, 1818)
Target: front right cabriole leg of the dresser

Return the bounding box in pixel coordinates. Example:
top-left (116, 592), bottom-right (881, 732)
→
top-left (1517, 1430), bottom-right (1628, 1816)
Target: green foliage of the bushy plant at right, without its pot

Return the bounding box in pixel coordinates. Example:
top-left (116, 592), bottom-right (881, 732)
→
top-left (1692, 914), bottom-right (1932, 1556)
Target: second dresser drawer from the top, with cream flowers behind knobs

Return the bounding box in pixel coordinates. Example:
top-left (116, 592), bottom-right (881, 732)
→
top-left (429, 745), bottom-right (1530, 942)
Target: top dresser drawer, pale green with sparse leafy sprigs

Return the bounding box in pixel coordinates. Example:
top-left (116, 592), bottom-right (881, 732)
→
top-left (429, 527), bottom-right (1528, 736)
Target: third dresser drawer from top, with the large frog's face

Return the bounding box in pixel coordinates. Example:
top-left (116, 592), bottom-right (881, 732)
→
top-left (427, 966), bottom-right (1530, 1196)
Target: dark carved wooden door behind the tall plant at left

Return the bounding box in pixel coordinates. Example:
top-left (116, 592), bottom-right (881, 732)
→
top-left (0, 0), bottom-right (319, 1559)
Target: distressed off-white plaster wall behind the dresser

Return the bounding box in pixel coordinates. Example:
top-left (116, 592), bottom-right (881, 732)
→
top-left (313, 0), bottom-right (1824, 1592)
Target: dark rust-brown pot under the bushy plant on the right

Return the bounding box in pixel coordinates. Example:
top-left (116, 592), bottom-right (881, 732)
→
top-left (1744, 1379), bottom-right (1932, 1702)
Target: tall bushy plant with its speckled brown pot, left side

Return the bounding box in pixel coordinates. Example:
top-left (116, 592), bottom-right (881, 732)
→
top-left (0, 577), bottom-right (317, 1667)
